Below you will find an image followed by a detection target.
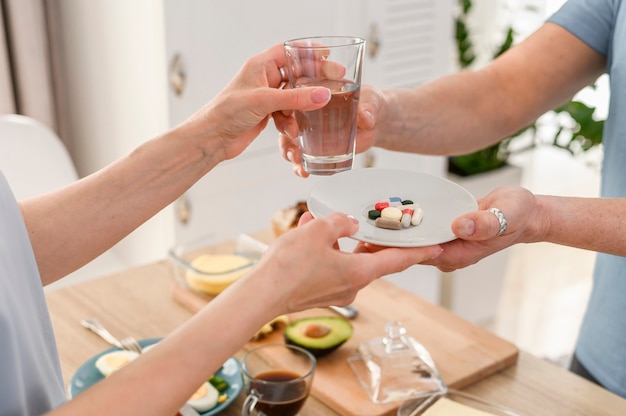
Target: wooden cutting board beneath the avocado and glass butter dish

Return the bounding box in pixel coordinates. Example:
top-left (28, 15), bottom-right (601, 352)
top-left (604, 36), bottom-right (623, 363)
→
top-left (174, 280), bottom-right (518, 416)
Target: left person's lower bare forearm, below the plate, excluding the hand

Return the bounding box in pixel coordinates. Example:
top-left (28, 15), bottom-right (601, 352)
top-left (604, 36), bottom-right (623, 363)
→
top-left (47, 270), bottom-right (284, 416)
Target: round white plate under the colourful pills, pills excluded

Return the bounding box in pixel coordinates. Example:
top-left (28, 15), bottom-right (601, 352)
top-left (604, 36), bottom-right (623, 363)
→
top-left (307, 168), bottom-right (478, 247)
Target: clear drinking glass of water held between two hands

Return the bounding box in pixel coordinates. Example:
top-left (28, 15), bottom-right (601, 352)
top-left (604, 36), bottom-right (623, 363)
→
top-left (284, 36), bottom-right (365, 175)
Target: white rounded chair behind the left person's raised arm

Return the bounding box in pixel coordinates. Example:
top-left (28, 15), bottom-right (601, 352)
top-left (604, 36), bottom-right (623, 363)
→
top-left (0, 114), bottom-right (125, 289)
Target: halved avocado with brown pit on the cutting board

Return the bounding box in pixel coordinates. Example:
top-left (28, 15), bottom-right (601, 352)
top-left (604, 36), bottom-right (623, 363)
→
top-left (284, 316), bottom-right (352, 357)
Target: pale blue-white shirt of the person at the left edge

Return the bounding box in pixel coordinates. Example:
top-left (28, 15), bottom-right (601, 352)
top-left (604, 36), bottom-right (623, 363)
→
top-left (0, 172), bottom-right (65, 416)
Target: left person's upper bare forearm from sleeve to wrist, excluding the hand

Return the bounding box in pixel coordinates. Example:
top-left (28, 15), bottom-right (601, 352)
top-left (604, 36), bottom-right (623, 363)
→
top-left (21, 125), bottom-right (220, 284)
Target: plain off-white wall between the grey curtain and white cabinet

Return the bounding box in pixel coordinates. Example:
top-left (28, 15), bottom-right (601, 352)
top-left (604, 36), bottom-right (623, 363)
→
top-left (51, 0), bottom-right (168, 176)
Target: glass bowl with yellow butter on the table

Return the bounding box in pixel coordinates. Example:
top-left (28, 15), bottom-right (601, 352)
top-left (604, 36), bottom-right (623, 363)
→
top-left (168, 233), bottom-right (267, 296)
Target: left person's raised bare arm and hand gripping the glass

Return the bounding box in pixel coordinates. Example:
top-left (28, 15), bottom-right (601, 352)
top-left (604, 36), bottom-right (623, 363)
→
top-left (21, 44), bottom-right (330, 284)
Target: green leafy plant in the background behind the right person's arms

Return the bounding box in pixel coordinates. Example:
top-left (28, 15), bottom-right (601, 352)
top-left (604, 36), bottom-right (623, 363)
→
top-left (448, 0), bottom-right (604, 176)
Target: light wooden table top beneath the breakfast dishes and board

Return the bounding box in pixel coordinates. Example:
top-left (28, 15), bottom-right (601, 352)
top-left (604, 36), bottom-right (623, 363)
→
top-left (46, 239), bottom-right (626, 416)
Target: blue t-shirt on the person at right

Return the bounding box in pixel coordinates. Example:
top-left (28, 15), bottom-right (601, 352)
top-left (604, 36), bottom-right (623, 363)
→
top-left (550, 0), bottom-right (626, 397)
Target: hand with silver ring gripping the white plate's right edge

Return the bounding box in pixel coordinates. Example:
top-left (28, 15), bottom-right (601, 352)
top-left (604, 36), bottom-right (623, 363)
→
top-left (423, 186), bottom-right (540, 272)
